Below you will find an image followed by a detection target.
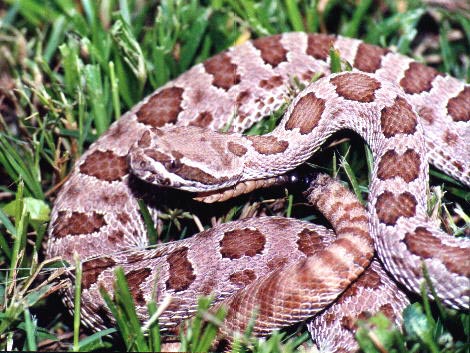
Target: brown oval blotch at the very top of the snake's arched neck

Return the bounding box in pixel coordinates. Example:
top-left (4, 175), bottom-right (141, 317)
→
top-left (330, 73), bottom-right (381, 103)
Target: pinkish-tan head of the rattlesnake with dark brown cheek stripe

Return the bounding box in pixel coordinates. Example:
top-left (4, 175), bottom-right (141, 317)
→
top-left (128, 126), bottom-right (246, 192)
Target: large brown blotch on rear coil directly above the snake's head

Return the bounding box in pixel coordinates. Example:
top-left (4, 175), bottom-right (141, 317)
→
top-left (136, 87), bottom-right (184, 127)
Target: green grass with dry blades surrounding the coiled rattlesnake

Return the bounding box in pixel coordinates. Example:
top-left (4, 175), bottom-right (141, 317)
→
top-left (0, 0), bottom-right (470, 352)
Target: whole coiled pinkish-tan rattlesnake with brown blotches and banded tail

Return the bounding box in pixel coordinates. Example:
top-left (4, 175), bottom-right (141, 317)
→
top-left (47, 33), bottom-right (470, 350)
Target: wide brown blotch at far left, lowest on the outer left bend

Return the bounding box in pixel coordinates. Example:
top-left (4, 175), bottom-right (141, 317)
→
top-left (52, 211), bottom-right (106, 238)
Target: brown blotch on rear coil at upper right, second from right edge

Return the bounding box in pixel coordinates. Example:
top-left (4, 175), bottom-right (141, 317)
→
top-left (400, 62), bottom-right (439, 94)
